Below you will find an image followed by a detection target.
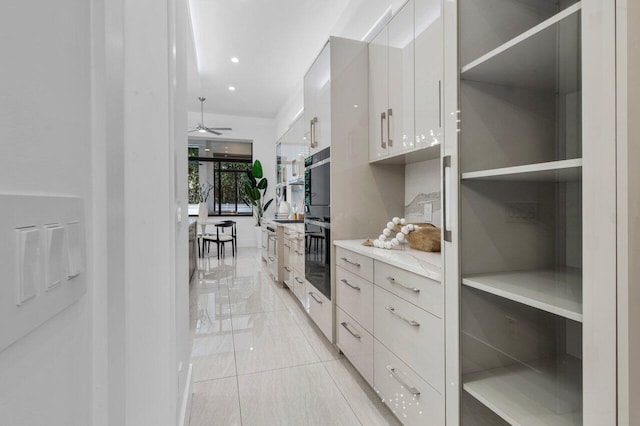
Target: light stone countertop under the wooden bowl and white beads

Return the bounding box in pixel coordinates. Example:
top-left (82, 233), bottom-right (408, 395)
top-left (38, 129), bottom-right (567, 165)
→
top-left (333, 239), bottom-right (442, 281)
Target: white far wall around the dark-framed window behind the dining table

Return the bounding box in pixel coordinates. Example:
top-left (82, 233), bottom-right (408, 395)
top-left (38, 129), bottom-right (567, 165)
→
top-left (184, 112), bottom-right (276, 247)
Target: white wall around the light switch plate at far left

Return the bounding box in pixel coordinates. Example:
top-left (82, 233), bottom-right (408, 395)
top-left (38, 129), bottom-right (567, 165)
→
top-left (0, 0), bottom-right (96, 426)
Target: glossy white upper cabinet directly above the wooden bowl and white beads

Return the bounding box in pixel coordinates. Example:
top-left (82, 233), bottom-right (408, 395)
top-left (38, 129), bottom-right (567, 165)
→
top-left (369, 0), bottom-right (443, 162)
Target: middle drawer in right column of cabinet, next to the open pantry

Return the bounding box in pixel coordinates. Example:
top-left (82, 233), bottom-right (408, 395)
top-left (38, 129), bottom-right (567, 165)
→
top-left (373, 286), bottom-right (444, 392)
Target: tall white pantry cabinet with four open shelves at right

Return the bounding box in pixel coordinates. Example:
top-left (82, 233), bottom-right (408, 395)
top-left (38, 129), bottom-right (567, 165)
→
top-left (442, 0), bottom-right (617, 425)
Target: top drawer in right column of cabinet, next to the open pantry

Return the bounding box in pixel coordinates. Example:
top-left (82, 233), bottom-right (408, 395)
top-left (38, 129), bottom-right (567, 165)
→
top-left (374, 262), bottom-right (444, 318)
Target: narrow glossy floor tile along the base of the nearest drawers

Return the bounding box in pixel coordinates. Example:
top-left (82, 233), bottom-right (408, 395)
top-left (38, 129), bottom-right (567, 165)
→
top-left (322, 359), bottom-right (401, 426)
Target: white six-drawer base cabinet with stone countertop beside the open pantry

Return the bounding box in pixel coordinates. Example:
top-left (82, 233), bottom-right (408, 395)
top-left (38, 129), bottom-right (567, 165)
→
top-left (336, 241), bottom-right (445, 425)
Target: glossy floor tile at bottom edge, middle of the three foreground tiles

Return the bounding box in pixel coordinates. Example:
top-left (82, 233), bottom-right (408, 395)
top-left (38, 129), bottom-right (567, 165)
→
top-left (238, 364), bottom-right (360, 426)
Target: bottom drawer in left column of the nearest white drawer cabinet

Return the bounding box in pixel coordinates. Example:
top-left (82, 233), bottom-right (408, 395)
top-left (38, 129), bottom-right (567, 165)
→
top-left (336, 308), bottom-right (373, 386)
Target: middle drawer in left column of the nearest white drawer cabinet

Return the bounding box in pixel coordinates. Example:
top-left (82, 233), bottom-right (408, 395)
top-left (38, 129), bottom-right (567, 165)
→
top-left (336, 266), bottom-right (373, 333)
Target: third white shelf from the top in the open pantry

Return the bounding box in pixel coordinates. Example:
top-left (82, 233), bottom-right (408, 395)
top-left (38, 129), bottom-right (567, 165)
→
top-left (462, 268), bottom-right (582, 322)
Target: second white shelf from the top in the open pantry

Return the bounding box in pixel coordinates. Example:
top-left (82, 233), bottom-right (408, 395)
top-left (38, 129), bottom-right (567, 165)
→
top-left (462, 158), bottom-right (582, 182)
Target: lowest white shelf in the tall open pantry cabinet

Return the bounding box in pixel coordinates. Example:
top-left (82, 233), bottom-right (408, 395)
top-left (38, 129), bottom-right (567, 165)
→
top-left (463, 355), bottom-right (582, 426)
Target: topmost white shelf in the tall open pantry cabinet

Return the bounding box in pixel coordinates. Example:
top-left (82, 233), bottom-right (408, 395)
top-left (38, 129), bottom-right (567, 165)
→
top-left (460, 2), bottom-right (582, 92)
